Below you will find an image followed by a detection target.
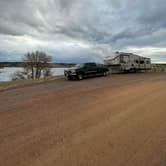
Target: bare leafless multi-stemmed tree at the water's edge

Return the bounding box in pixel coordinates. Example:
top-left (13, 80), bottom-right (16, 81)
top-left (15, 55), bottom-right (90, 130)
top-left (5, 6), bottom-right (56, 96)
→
top-left (23, 51), bottom-right (52, 79)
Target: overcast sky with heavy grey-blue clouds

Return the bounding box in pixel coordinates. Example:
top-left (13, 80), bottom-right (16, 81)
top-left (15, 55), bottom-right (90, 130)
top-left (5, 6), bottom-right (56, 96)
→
top-left (0, 0), bottom-right (166, 62)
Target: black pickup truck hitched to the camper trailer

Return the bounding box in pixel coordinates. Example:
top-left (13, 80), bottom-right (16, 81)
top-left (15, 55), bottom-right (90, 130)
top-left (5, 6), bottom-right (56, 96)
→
top-left (64, 63), bottom-right (108, 80)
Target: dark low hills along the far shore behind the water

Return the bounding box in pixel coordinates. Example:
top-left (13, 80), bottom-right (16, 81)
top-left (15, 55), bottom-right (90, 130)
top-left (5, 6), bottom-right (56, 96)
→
top-left (0, 62), bottom-right (75, 68)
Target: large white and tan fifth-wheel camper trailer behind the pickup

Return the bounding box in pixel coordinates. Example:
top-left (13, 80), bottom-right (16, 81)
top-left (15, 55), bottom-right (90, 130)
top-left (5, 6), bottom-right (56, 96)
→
top-left (104, 52), bottom-right (151, 72)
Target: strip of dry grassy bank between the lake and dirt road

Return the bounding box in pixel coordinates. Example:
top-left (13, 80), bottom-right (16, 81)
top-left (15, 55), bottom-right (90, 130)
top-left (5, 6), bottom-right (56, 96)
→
top-left (0, 76), bottom-right (64, 92)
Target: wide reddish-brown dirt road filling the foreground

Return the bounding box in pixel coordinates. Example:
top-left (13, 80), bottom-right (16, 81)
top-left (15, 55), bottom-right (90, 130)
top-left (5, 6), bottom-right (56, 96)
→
top-left (0, 73), bottom-right (166, 166)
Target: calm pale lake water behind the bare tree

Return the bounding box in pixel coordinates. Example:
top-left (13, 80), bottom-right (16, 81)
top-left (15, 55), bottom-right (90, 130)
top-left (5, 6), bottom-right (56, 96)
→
top-left (0, 67), bottom-right (66, 82)
